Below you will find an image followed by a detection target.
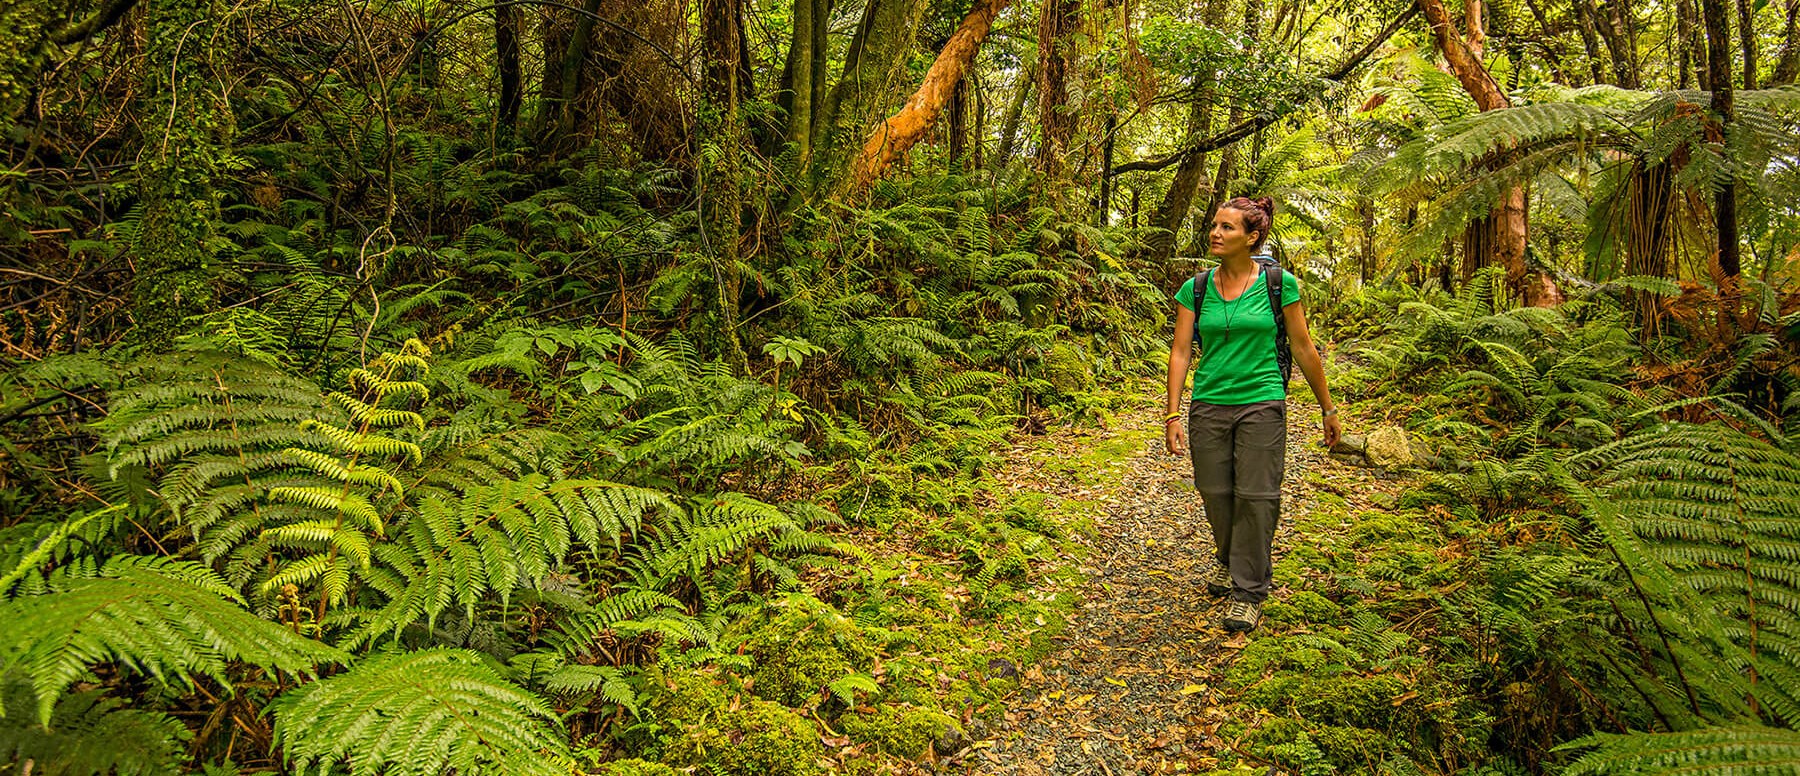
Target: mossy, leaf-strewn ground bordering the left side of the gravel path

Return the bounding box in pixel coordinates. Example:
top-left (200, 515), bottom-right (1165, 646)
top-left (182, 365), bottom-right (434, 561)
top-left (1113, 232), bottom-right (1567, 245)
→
top-left (601, 392), bottom-right (1125, 776)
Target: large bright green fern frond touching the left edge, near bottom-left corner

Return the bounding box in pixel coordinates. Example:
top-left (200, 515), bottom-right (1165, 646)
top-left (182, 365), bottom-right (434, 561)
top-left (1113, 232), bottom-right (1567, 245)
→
top-left (0, 558), bottom-right (346, 722)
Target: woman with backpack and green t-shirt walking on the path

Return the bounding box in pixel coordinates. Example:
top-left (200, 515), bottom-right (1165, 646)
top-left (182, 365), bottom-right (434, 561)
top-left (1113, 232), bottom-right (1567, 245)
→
top-left (1165, 196), bottom-right (1343, 630)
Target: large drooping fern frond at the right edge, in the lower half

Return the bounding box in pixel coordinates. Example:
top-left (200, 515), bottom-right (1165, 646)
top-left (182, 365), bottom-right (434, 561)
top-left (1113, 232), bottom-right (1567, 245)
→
top-left (1571, 423), bottom-right (1800, 727)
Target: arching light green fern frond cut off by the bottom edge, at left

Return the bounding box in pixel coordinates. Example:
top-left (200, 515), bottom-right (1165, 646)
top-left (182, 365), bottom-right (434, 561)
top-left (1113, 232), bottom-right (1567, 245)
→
top-left (268, 648), bottom-right (574, 776)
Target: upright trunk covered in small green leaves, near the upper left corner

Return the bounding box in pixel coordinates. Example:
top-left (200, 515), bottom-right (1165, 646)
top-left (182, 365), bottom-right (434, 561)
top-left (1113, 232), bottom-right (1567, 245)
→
top-left (131, 0), bottom-right (234, 346)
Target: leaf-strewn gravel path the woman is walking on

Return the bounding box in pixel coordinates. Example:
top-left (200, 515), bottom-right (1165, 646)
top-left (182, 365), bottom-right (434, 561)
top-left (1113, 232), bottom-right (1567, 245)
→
top-left (963, 398), bottom-right (1366, 776)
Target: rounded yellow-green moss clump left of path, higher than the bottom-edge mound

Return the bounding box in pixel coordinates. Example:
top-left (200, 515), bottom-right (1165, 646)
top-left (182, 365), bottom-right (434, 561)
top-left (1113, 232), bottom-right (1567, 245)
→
top-left (727, 594), bottom-right (877, 706)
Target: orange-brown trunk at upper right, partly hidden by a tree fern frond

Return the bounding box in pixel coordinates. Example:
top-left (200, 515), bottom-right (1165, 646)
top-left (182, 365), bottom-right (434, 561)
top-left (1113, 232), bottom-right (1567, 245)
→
top-left (1418, 0), bottom-right (1562, 306)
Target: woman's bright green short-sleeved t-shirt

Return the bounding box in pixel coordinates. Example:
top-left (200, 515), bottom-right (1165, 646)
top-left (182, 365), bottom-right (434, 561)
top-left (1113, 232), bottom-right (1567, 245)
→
top-left (1175, 266), bottom-right (1300, 405)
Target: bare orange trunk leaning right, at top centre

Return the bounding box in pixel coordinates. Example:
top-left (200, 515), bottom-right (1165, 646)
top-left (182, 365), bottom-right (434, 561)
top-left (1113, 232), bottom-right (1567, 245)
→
top-left (844, 0), bottom-right (1010, 193)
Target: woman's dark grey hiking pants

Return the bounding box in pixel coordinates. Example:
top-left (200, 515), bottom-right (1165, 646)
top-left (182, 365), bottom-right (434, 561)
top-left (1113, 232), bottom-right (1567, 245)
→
top-left (1188, 400), bottom-right (1287, 603)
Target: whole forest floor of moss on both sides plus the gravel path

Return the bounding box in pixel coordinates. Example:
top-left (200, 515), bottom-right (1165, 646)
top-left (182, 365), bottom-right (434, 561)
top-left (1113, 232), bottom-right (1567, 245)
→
top-left (612, 374), bottom-right (1526, 776)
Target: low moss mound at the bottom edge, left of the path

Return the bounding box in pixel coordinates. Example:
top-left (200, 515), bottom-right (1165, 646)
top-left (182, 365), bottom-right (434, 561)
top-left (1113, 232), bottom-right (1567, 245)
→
top-left (662, 699), bottom-right (824, 776)
